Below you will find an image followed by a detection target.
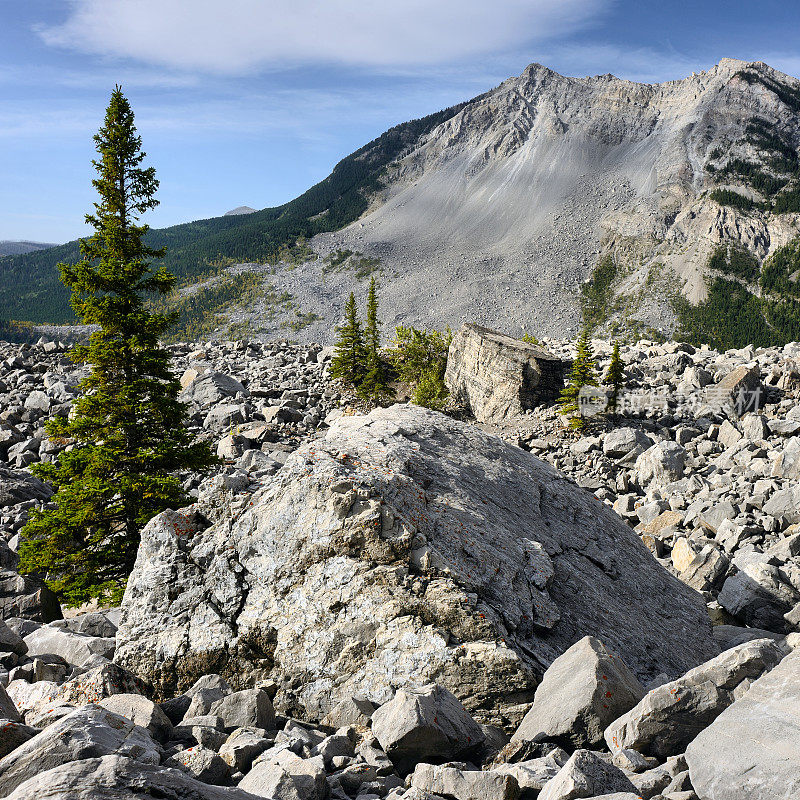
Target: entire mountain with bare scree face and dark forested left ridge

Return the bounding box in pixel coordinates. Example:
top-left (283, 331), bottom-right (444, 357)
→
top-left (7, 59), bottom-right (800, 346)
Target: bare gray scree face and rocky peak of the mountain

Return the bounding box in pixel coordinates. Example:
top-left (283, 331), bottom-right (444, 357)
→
top-left (272, 59), bottom-right (800, 344)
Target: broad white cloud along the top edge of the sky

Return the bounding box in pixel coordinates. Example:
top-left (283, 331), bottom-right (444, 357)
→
top-left (34, 0), bottom-right (612, 74)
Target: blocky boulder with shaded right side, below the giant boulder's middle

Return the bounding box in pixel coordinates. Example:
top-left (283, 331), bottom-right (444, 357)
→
top-left (372, 685), bottom-right (485, 772)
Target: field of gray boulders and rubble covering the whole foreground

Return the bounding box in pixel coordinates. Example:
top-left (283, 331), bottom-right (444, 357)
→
top-left (0, 328), bottom-right (800, 800)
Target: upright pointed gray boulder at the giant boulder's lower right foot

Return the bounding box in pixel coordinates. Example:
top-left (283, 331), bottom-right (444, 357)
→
top-left (512, 636), bottom-right (645, 749)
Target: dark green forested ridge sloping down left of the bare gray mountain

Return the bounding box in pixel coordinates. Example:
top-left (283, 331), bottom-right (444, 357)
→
top-left (0, 104), bottom-right (464, 323)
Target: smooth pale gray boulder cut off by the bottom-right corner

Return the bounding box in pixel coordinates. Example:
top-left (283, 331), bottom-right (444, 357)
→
top-left (686, 650), bottom-right (800, 800)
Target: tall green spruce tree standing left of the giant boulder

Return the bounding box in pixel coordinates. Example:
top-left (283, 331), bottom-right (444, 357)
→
top-left (20, 86), bottom-right (216, 605)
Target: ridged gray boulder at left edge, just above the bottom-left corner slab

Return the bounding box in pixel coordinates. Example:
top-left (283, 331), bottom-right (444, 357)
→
top-left (0, 705), bottom-right (161, 797)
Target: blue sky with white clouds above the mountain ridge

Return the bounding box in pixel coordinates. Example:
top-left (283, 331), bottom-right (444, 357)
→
top-left (0, 0), bottom-right (800, 242)
